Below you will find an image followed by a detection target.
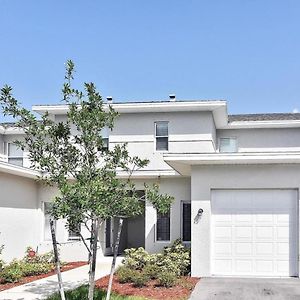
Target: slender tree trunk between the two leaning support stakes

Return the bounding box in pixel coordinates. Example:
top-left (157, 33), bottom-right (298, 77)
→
top-left (88, 219), bottom-right (100, 300)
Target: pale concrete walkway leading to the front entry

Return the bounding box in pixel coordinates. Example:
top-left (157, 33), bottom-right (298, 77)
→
top-left (0, 257), bottom-right (123, 300)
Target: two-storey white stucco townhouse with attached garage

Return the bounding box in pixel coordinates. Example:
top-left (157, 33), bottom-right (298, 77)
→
top-left (0, 97), bottom-right (300, 277)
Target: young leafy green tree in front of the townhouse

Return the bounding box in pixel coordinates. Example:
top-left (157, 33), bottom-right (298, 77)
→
top-left (0, 61), bottom-right (173, 300)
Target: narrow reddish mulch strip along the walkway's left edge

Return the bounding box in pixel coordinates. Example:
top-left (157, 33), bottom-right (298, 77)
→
top-left (0, 261), bottom-right (87, 292)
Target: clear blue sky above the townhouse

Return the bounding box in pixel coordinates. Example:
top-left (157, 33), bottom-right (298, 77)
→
top-left (0, 0), bottom-right (300, 120)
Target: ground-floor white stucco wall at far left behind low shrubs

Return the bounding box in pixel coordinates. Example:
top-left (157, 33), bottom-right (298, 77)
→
top-left (0, 173), bottom-right (40, 261)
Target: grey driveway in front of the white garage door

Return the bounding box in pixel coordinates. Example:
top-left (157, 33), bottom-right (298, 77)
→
top-left (190, 278), bottom-right (300, 300)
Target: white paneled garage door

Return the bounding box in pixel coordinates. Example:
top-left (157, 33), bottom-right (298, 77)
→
top-left (211, 190), bottom-right (298, 276)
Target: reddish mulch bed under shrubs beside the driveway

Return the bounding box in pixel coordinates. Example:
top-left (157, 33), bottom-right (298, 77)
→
top-left (96, 276), bottom-right (199, 300)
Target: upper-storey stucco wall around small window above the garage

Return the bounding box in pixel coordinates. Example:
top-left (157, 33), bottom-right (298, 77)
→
top-left (217, 128), bottom-right (300, 152)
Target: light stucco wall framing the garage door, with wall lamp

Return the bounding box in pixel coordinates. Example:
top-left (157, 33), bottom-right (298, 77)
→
top-left (191, 165), bottom-right (300, 276)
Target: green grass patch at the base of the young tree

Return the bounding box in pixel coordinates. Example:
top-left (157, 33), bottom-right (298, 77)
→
top-left (47, 285), bottom-right (146, 300)
